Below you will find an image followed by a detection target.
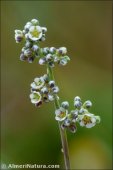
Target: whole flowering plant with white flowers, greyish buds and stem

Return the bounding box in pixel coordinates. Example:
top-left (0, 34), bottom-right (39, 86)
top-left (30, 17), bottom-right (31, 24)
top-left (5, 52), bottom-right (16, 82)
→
top-left (15, 19), bottom-right (100, 170)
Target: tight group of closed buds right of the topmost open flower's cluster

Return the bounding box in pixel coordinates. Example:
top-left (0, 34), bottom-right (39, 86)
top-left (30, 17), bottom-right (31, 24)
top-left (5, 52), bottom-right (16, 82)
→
top-left (39, 47), bottom-right (70, 67)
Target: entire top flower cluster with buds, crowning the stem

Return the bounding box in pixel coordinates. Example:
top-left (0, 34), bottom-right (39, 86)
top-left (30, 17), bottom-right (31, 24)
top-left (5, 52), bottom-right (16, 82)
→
top-left (15, 19), bottom-right (70, 67)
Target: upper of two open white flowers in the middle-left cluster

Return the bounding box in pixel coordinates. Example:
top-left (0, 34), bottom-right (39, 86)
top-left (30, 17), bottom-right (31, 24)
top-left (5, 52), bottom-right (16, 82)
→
top-left (31, 77), bottom-right (45, 90)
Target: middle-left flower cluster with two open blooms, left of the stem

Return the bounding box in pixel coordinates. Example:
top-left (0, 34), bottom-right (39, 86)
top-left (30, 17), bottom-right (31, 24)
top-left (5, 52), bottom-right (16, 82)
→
top-left (30, 74), bottom-right (59, 106)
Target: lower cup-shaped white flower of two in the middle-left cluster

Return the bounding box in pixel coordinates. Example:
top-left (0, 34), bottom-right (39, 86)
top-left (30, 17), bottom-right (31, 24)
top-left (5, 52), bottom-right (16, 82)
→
top-left (30, 91), bottom-right (41, 104)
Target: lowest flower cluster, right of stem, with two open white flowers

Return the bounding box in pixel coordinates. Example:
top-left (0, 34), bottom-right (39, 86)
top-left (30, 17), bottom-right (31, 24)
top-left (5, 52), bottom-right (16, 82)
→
top-left (55, 96), bottom-right (100, 133)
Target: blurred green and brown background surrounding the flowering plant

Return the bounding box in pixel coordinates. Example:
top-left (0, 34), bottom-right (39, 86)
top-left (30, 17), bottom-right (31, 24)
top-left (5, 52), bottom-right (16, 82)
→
top-left (1, 1), bottom-right (112, 170)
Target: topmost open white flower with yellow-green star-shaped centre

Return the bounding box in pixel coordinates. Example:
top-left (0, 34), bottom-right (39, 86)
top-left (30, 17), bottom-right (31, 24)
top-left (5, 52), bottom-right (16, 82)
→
top-left (28, 26), bottom-right (42, 41)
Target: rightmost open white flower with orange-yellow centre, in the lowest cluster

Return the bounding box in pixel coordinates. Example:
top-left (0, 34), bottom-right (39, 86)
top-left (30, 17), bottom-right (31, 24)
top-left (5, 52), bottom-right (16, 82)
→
top-left (78, 113), bottom-right (100, 128)
